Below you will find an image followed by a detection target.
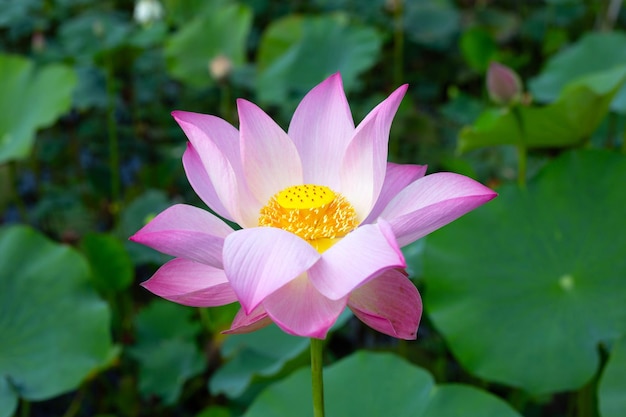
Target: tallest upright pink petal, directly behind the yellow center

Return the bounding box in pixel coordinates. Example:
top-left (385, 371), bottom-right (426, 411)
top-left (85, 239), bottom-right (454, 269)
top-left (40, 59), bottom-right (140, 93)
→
top-left (289, 73), bottom-right (354, 189)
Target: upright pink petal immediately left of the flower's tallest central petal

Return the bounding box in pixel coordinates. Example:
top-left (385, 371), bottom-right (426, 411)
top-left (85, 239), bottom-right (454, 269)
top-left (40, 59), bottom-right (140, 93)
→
top-left (237, 99), bottom-right (302, 204)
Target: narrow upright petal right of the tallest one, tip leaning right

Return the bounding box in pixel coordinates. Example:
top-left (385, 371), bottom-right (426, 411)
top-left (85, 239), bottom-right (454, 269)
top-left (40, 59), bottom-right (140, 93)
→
top-left (339, 85), bottom-right (407, 221)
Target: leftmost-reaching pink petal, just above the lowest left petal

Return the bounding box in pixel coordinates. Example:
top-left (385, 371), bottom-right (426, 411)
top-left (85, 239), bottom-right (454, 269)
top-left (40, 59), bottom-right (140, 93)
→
top-left (130, 204), bottom-right (233, 268)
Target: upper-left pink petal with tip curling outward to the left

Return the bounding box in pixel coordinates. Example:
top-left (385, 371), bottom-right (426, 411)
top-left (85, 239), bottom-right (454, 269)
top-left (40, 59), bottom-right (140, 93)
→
top-left (172, 111), bottom-right (258, 227)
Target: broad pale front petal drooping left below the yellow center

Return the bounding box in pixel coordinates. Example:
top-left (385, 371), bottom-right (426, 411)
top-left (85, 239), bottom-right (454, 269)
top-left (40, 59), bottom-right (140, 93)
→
top-left (224, 227), bottom-right (320, 313)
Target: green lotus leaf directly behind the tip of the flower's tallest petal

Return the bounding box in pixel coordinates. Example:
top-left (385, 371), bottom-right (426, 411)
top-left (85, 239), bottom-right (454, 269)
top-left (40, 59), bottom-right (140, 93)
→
top-left (256, 14), bottom-right (382, 104)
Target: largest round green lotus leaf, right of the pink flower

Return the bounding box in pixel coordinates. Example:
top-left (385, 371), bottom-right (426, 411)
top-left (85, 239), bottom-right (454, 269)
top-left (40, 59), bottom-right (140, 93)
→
top-left (424, 151), bottom-right (626, 394)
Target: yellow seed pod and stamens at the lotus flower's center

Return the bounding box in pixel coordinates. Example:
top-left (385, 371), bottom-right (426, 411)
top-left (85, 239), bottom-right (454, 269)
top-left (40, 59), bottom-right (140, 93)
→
top-left (259, 184), bottom-right (359, 252)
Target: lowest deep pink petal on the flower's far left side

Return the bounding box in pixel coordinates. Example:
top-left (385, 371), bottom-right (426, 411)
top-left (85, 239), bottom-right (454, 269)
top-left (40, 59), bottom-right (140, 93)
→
top-left (141, 258), bottom-right (237, 307)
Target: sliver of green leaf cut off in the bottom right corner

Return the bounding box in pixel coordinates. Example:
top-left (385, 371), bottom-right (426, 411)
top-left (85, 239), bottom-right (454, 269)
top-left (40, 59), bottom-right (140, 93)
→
top-left (598, 337), bottom-right (626, 417)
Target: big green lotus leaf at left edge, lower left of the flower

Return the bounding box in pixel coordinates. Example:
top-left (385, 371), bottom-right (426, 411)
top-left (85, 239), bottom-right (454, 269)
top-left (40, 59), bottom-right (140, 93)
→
top-left (0, 226), bottom-right (112, 417)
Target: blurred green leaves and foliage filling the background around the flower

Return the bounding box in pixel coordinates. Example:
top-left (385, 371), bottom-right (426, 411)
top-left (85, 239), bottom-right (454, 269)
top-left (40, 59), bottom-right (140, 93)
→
top-left (0, 0), bottom-right (626, 417)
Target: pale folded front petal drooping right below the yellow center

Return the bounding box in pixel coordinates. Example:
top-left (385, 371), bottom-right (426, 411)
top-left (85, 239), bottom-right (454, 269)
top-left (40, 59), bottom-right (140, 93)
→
top-left (309, 220), bottom-right (406, 300)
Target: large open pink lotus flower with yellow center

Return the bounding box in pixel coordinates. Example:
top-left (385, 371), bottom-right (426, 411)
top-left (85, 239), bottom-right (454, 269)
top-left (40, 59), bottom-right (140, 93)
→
top-left (131, 74), bottom-right (496, 339)
